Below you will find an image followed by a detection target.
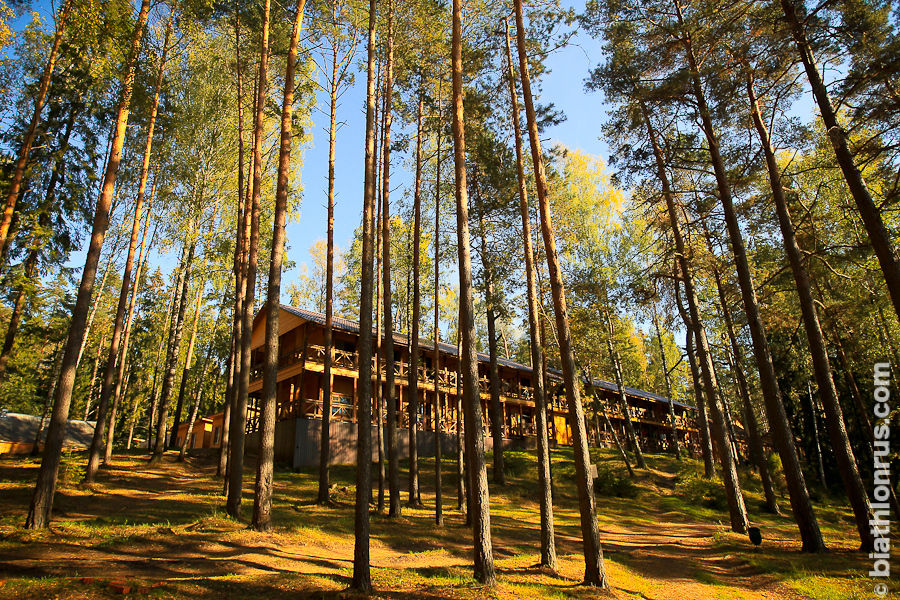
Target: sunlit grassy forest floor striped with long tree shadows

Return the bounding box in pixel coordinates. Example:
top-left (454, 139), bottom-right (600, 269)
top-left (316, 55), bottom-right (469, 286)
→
top-left (0, 448), bottom-right (900, 600)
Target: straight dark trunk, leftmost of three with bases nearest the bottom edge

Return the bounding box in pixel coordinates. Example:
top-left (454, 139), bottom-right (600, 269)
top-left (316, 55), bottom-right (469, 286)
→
top-left (350, 0), bottom-right (381, 593)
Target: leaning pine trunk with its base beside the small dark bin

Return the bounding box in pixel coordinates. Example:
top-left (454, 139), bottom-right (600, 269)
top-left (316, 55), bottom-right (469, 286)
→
top-left (640, 95), bottom-right (748, 533)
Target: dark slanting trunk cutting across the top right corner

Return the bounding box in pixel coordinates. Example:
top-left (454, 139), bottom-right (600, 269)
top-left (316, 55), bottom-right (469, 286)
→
top-left (780, 0), bottom-right (900, 326)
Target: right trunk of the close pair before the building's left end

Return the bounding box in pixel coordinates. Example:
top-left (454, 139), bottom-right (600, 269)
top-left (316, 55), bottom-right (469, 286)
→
top-left (251, 0), bottom-right (306, 531)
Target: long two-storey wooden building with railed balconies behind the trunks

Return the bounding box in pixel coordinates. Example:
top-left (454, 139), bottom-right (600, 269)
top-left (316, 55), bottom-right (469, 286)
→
top-left (234, 305), bottom-right (699, 466)
